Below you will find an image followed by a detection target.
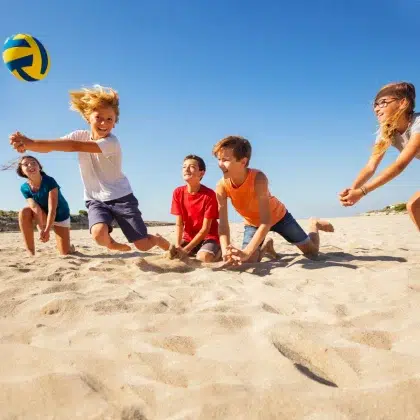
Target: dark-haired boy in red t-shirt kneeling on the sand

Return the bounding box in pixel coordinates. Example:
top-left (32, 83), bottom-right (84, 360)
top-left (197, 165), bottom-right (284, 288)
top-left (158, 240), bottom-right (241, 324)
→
top-left (171, 155), bottom-right (221, 262)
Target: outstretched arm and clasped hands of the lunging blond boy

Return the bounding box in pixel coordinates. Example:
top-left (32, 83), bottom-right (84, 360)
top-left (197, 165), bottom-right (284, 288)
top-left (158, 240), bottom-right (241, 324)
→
top-left (10, 131), bottom-right (102, 153)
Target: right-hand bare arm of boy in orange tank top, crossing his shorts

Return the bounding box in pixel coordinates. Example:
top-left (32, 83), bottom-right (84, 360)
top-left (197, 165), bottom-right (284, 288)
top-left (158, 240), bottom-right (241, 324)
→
top-left (244, 172), bottom-right (271, 256)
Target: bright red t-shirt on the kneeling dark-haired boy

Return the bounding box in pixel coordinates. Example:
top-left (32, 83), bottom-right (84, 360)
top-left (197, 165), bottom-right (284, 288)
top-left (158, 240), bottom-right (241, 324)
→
top-left (171, 185), bottom-right (219, 242)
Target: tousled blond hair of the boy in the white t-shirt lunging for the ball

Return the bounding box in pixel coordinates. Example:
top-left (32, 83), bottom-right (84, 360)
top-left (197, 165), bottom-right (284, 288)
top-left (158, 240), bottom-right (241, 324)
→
top-left (70, 85), bottom-right (120, 123)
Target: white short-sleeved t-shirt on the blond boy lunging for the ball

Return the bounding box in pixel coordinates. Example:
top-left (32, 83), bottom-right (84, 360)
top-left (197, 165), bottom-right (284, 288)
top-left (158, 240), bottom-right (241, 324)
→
top-left (62, 130), bottom-right (133, 201)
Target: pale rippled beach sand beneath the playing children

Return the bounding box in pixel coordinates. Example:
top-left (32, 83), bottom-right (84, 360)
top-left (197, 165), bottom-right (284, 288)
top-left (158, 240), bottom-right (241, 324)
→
top-left (0, 215), bottom-right (420, 420)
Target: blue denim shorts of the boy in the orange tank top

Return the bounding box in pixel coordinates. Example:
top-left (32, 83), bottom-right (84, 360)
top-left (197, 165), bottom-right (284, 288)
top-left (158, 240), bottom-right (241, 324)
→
top-left (242, 212), bottom-right (310, 248)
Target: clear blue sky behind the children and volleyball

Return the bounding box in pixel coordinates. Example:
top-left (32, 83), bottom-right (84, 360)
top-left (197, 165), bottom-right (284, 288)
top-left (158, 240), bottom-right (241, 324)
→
top-left (0, 0), bottom-right (420, 221)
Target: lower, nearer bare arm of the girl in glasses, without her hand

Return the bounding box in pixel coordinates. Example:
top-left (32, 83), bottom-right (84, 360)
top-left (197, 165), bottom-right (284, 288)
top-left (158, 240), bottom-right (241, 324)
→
top-left (365, 133), bottom-right (420, 192)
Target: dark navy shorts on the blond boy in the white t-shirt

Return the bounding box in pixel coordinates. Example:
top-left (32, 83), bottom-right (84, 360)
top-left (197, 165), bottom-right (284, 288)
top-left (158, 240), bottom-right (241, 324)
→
top-left (86, 194), bottom-right (147, 242)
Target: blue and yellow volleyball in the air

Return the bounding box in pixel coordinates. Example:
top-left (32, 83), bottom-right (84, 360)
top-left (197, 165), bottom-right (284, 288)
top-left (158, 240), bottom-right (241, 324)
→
top-left (3, 34), bottom-right (50, 82)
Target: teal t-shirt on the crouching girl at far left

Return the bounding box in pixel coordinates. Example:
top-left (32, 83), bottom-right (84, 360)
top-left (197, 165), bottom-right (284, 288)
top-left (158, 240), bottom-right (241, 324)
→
top-left (20, 174), bottom-right (70, 222)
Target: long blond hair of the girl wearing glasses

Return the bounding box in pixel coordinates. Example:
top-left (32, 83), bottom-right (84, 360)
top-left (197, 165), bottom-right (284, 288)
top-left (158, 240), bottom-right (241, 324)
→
top-left (373, 82), bottom-right (416, 154)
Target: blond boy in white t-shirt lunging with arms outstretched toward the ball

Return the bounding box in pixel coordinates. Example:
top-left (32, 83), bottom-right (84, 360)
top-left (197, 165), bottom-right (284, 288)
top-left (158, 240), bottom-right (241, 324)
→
top-left (10, 86), bottom-right (169, 251)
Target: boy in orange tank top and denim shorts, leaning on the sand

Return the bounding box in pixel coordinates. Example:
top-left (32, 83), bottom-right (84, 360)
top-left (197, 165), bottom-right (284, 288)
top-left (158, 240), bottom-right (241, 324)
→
top-left (213, 136), bottom-right (334, 264)
